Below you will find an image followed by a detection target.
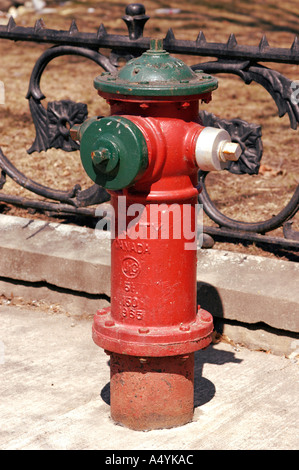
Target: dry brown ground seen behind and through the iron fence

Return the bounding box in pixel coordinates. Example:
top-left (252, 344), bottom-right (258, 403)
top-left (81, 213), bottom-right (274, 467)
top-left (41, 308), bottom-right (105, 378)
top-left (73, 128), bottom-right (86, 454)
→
top-left (0, 0), bottom-right (299, 256)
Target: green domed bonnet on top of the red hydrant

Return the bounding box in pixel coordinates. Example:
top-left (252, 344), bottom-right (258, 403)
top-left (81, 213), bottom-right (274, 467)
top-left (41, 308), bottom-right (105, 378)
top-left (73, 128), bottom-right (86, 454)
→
top-left (94, 39), bottom-right (218, 96)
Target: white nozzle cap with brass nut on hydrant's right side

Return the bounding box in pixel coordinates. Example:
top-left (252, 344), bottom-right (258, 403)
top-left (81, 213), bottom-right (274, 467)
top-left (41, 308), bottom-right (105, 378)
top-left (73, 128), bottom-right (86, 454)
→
top-left (195, 127), bottom-right (242, 171)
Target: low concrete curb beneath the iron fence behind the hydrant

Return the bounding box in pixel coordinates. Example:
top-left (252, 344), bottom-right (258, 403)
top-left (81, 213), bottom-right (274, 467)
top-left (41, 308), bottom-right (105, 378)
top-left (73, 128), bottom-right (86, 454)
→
top-left (0, 215), bottom-right (299, 355)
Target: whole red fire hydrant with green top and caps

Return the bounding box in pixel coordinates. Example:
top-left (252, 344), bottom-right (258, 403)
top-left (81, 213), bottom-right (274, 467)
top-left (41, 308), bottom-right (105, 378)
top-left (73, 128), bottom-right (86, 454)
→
top-left (71, 40), bottom-right (241, 430)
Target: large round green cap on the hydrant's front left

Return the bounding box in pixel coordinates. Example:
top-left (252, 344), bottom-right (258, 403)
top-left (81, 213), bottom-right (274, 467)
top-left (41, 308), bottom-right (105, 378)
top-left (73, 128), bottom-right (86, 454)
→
top-left (78, 116), bottom-right (148, 190)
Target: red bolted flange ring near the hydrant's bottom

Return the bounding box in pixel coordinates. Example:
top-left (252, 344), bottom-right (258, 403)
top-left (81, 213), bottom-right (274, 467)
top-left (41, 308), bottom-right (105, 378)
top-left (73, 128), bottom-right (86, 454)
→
top-left (92, 307), bottom-right (213, 357)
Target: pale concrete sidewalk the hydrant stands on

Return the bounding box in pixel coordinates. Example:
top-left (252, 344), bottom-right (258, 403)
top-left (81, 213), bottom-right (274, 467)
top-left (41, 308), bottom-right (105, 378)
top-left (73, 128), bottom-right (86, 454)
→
top-left (0, 305), bottom-right (299, 450)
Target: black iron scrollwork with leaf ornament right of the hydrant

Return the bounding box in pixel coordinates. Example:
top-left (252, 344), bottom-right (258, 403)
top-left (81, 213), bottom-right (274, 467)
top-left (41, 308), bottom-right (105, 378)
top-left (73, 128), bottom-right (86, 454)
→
top-left (196, 60), bottom-right (299, 239)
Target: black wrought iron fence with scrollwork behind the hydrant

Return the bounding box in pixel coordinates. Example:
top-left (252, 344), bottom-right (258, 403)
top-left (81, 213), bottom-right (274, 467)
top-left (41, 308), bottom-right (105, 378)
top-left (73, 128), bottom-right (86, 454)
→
top-left (0, 3), bottom-right (299, 251)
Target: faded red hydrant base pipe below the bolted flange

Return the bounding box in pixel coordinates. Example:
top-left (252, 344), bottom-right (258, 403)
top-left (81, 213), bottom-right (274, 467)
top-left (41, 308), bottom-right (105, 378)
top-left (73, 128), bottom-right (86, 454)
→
top-left (110, 353), bottom-right (194, 431)
